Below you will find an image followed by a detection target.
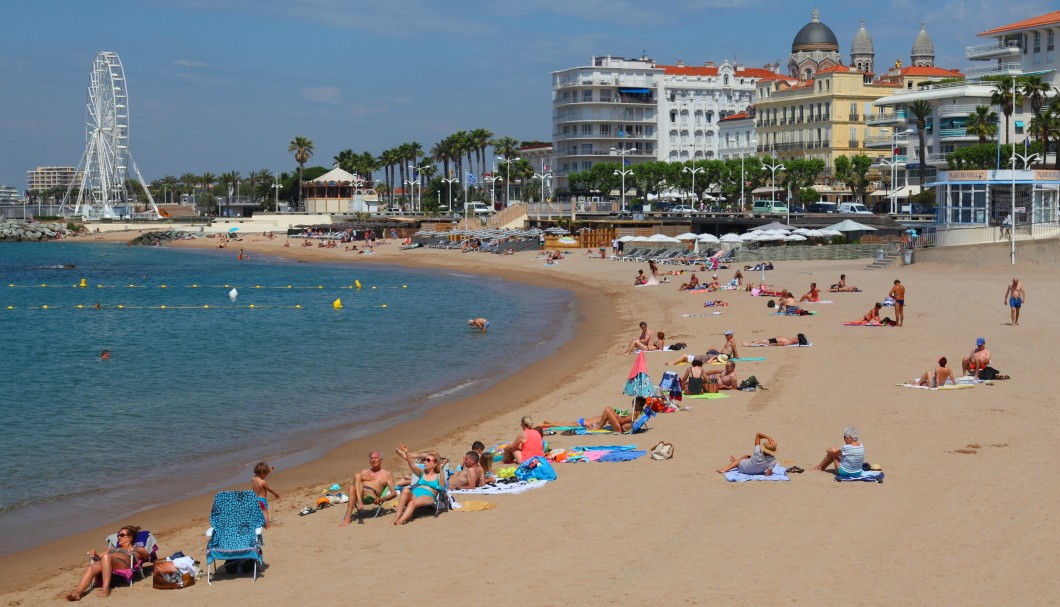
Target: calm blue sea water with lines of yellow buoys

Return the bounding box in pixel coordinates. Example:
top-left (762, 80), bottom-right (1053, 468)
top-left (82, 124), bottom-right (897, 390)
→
top-left (0, 243), bottom-right (573, 554)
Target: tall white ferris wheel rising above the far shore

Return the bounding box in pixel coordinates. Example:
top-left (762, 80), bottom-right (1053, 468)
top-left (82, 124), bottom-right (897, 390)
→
top-left (63, 51), bottom-right (161, 219)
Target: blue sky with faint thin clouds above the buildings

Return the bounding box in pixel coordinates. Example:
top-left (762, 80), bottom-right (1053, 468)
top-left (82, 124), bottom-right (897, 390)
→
top-left (0, 0), bottom-right (1056, 191)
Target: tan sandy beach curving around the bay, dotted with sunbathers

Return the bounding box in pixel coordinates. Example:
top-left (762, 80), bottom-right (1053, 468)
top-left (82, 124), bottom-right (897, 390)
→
top-left (0, 233), bottom-right (1060, 606)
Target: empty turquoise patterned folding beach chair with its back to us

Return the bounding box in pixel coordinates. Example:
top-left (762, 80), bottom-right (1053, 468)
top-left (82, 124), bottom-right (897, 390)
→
top-left (206, 490), bottom-right (265, 584)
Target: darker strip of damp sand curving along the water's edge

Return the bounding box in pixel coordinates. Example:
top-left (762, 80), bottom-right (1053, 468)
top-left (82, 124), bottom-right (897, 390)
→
top-left (0, 232), bottom-right (619, 595)
